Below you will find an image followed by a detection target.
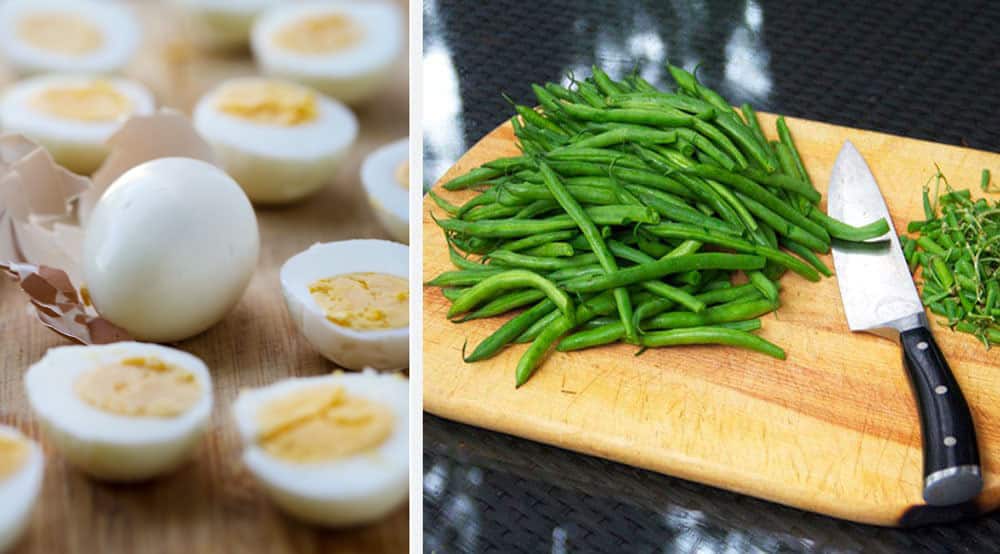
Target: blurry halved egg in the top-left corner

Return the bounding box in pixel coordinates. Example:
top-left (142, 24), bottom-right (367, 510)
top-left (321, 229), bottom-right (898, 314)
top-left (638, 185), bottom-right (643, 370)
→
top-left (0, 0), bottom-right (140, 74)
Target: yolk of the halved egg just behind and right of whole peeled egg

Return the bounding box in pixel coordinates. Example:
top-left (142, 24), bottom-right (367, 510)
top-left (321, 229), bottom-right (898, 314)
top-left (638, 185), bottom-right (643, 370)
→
top-left (215, 80), bottom-right (319, 127)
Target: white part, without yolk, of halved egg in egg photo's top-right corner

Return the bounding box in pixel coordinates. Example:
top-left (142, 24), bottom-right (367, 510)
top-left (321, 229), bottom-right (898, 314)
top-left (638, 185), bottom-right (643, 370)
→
top-left (250, 0), bottom-right (403, 104)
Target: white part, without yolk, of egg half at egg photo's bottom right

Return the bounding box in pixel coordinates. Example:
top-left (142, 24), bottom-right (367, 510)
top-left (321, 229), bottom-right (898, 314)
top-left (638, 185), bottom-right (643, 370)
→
top-left (233, 371), bottom-right (409, 526)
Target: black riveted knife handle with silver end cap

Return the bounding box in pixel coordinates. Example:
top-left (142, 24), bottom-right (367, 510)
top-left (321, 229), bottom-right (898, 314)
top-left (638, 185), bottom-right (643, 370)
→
top-left (900, 327), bottom-right (983, 506)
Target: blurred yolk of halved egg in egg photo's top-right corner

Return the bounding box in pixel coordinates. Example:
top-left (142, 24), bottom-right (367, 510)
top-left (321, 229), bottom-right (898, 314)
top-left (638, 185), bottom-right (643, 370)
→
top-left (274, 13), bottom-right (364, 55)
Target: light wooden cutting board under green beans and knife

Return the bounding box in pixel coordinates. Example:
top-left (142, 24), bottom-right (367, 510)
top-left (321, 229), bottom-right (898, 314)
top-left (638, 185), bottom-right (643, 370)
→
top-left (423, 114), bottom-right (1000, 526)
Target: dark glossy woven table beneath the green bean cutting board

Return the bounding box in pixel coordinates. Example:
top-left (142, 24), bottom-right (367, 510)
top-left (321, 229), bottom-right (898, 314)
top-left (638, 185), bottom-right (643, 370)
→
top-left (424, 0), bottom-right (1000, 553)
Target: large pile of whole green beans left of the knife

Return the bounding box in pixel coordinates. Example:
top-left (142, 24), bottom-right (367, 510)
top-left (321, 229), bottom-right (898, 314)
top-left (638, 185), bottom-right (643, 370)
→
top-left (428, 66), bottom-right (888, 386)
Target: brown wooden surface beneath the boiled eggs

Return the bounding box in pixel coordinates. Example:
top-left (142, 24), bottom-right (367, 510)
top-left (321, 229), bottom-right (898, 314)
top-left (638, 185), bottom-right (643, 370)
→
top-left (0, 0), bottom-right (409, 554)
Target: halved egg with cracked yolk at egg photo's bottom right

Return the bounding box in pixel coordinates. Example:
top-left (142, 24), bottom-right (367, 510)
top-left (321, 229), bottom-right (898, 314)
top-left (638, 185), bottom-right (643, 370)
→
top-left (233, 371), bottom-right (409, 526)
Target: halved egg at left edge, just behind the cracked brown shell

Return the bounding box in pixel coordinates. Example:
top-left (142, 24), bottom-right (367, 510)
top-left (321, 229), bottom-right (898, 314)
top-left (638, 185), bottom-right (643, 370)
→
top-left (0, 75), bottom-right (155, 174)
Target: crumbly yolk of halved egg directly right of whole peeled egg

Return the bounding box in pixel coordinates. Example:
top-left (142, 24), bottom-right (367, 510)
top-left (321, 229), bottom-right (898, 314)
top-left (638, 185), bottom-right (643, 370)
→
top-left (309, 273), bottom-right (410, 331)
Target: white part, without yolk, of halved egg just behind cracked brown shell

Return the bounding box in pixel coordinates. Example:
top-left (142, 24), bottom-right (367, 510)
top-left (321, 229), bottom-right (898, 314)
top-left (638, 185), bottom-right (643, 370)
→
top-left (0, 75), bottom-right (156, 174)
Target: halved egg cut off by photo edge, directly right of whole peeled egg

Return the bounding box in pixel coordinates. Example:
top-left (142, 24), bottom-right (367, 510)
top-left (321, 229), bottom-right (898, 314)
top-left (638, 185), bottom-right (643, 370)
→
top-left (281, 239), bottom-right (410, 370)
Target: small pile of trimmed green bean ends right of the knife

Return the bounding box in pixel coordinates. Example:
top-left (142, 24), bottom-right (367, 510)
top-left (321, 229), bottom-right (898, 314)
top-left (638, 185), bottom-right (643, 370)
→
top-left (899, 169), bottom-right (1000, 349)
